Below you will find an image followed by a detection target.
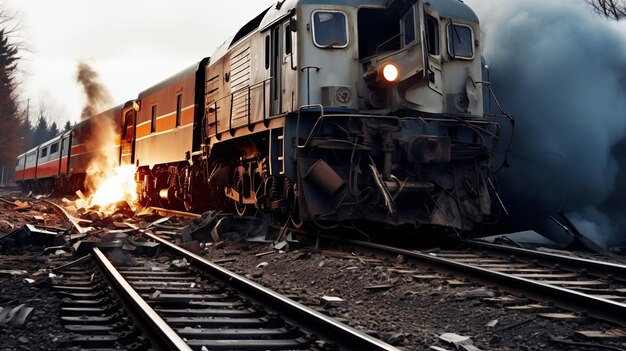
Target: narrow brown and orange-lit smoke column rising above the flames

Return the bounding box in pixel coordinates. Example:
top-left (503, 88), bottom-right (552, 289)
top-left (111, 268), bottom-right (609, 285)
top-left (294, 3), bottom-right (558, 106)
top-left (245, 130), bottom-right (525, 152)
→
top-left (76, 62), bottom-right (119, 193)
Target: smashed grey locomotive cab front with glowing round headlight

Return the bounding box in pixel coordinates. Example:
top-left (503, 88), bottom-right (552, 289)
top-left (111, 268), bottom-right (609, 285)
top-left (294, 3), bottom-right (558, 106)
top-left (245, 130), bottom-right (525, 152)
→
top-left (359, 0), bottom-right (483, 117)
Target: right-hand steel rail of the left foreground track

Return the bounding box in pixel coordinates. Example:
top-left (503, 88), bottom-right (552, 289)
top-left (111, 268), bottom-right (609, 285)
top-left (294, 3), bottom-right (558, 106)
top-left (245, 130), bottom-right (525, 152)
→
top-left (143, 232), bottom-right (398, 351)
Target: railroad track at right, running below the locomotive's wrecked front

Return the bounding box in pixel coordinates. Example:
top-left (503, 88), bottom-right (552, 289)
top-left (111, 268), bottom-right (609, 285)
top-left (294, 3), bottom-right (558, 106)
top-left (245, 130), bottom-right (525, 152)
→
top-left (320, 235), bottom-right (626, 326)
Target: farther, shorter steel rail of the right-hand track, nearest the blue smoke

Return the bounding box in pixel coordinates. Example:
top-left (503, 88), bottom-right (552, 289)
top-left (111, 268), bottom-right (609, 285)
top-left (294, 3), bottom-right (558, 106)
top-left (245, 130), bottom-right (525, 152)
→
top-left (464, 240), bottom-right (626, 281)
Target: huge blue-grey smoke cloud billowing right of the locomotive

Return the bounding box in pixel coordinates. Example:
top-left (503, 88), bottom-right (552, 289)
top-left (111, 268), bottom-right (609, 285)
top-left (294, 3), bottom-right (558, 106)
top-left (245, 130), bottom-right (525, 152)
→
top-left (466, 0), bottom-right (626, 245)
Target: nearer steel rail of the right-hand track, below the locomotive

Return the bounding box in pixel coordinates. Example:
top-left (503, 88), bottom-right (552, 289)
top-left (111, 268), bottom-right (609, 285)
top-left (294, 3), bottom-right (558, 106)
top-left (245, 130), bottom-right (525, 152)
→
top-left (317, 234), bottom-right (626, 326)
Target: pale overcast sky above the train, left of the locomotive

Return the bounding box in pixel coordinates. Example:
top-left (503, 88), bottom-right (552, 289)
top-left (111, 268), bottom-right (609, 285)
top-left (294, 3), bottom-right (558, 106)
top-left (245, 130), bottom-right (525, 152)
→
top-left (4, 0), bottom-right (274, 125)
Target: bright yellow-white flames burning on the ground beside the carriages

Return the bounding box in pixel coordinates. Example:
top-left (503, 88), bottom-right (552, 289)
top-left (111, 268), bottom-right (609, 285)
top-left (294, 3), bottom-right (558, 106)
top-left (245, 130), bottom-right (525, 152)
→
top-left (91, 165), bottom-right (137, 210)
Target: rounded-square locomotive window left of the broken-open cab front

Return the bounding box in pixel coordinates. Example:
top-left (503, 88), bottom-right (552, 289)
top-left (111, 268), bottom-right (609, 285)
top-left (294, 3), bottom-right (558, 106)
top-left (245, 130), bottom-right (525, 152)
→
top-left (313, 11), bottom-right (348, 49)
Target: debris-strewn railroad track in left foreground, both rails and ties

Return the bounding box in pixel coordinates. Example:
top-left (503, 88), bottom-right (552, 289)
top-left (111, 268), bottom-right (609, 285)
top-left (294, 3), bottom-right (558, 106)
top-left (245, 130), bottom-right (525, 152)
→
top-left (46, 202), bottom-right (397, 350)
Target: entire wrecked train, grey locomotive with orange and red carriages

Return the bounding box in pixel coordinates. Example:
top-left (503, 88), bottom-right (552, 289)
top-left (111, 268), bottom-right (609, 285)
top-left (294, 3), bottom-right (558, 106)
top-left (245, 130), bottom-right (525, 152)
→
top-left (16, 0), bottom-right (501, 233)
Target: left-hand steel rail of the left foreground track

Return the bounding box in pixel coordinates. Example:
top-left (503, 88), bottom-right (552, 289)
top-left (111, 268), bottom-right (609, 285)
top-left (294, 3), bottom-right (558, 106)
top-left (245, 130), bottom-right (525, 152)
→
top-left (92, 248), bottom-right (192, 350)
